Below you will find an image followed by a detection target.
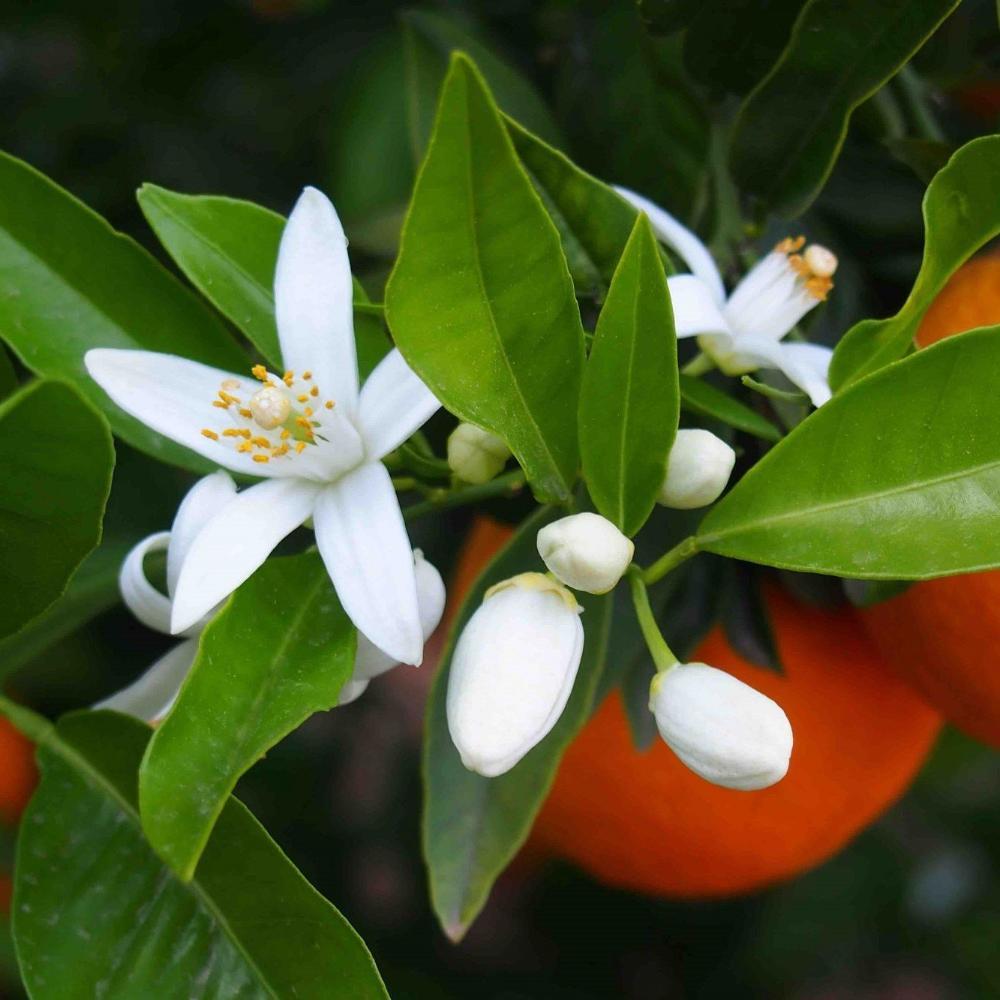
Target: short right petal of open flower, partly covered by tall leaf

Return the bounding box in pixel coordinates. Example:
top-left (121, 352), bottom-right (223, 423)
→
top-left (358, 348), bottom-right (441, 461)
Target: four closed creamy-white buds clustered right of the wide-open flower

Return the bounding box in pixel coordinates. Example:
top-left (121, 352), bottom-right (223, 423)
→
top-left (447, 422), bottom-right (792, 791)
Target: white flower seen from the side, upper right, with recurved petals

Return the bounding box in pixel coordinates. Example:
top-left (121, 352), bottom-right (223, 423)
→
top-left (616, 188), bottom-right (837, 406)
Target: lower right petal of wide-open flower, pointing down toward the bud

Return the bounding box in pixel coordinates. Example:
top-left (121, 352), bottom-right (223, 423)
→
top-left (313, 462), bottom-right (423, 664)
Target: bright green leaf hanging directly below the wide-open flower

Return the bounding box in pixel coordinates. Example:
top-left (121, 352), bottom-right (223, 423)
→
top-left (139, 552), bottom-right (356, 879)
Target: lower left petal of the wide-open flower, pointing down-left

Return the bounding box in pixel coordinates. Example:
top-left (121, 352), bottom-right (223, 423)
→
top-left (171, 479), bottom-right (322, 632)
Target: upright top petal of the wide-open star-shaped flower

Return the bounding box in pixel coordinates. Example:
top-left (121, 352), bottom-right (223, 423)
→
top-left (274, 187), bottom-right (358, 417)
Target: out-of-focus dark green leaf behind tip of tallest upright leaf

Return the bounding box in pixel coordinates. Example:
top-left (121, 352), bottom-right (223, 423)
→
top-left (400, 10), bottom-right (562, 163)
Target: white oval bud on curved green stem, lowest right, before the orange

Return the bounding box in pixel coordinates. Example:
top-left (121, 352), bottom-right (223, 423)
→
top-left (649, 663), bottom-right (792, 791)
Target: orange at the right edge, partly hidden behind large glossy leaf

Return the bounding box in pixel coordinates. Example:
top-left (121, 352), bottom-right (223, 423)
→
top-left (864, 256), bottom-right (1000, 746)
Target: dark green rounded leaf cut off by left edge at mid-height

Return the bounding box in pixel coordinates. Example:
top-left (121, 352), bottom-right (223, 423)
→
top-left (0, 378), bottom-right (115, 638)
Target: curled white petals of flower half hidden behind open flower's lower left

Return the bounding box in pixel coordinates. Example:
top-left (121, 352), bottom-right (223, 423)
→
top-left (95, 472), bottom-right (236, 722)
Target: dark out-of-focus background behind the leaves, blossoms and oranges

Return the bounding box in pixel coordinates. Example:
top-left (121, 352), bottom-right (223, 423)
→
top-left (0, 0), bottom-right (1000, 1000)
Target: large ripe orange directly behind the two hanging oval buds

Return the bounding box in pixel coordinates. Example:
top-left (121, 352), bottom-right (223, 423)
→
top-left (452, 519), bottom-right (940, 897)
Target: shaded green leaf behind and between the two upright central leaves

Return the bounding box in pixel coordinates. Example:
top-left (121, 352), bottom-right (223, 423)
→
top-left (505, 118), bottom-right (639, 300)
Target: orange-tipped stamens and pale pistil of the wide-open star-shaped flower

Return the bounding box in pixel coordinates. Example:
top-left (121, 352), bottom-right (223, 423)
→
top-left (201, 365), bottom-right (334, 464)
